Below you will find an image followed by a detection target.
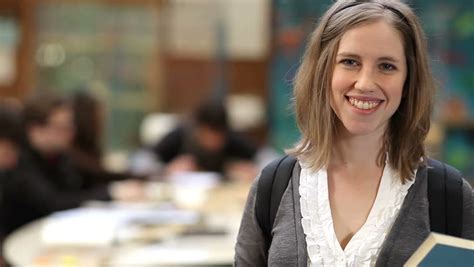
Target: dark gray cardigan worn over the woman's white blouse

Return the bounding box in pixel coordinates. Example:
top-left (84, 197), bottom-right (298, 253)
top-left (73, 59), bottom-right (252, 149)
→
top-left (235, 164), bottom-right (474, 266)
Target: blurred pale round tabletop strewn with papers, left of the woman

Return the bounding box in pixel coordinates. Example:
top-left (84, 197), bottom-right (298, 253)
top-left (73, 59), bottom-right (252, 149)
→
top-left (4, 179), bottom-right (250, 267)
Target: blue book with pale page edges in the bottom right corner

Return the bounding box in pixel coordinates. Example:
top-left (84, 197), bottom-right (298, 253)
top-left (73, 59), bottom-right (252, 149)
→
top-left (404, 232), bottom-right (474, 267)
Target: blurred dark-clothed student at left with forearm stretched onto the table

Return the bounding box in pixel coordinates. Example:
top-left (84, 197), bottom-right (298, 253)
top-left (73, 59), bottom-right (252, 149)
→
top-left (3, 94), bottom-right (143, 236)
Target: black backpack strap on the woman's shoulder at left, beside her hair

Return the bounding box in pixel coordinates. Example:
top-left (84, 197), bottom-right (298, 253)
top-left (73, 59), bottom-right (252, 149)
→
top-left (255, 155), bottom-right (296, 252)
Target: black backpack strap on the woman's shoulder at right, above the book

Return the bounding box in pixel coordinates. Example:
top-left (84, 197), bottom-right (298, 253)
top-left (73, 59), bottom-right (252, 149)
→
top-left (428, 159), bottom-right (463, 237)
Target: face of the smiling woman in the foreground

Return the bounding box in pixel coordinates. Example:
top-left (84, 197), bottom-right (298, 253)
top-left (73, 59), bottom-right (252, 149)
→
top-left (331, 21), bottom-right (407, 136)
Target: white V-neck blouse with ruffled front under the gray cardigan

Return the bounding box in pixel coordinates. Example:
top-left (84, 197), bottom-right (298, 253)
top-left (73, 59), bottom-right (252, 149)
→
top-left (299, 164), bottom-right (414, 266)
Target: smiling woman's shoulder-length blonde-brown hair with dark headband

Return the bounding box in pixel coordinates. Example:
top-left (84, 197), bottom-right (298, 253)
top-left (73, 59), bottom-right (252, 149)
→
top-left (288, 0), bottom-right (434, 182)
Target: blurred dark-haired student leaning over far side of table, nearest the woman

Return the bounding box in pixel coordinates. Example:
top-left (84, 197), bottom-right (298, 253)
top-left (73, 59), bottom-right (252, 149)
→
top-left (153, 102), bottom-right (257, 180)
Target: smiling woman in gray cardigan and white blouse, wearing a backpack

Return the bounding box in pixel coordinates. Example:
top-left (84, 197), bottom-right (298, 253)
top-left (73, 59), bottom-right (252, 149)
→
top-left (235, 0), bottom-right (474, 266)
